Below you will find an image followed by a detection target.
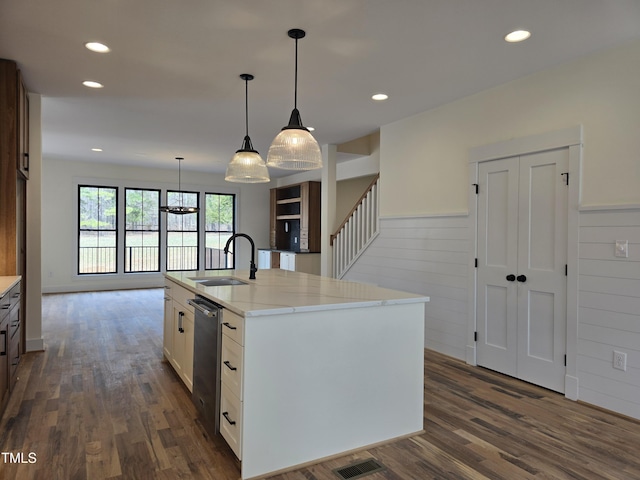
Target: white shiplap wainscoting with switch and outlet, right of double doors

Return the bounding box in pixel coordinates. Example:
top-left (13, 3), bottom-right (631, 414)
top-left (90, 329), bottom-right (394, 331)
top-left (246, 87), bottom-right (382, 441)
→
top-left (577, 208), bottom-right (640, 418)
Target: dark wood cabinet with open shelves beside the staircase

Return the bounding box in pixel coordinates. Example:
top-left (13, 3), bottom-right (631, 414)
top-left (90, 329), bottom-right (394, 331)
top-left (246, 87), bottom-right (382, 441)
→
top-left (269, 182), bottom-right (321, 252)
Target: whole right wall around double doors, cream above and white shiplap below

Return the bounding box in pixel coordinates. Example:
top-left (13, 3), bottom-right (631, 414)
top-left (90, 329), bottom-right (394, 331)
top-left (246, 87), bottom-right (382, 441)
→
top-left (346, 42), bottom-right (640, 418)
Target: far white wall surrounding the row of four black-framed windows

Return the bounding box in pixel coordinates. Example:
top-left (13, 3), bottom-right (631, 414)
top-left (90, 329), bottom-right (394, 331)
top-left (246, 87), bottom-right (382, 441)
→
top-left (42, 158), bottom-right (270, 293)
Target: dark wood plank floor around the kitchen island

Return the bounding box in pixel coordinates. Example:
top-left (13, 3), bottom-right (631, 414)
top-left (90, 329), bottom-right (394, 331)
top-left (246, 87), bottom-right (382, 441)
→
top-left (0, 289), bottom-right (640, 480)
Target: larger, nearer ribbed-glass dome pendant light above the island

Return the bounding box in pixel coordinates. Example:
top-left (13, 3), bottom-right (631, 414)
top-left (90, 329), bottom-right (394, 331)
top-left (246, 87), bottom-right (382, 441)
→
top-left (267, 28), bottom-right (322, 170)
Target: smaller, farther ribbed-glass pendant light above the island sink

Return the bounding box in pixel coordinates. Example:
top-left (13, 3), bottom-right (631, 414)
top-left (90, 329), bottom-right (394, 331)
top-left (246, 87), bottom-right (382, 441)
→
top-left (224, 73), bottom-right (270, 183)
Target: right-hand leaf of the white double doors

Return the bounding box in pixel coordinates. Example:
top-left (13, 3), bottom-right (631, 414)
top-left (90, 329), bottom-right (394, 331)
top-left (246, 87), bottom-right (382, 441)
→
top-left (517, 149), bottom-right (569, 392)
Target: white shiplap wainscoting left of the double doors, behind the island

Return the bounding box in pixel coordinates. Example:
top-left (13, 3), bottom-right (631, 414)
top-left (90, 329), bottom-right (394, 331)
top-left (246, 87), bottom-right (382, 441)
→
top-left (344, 214), bottom-right (471, 360)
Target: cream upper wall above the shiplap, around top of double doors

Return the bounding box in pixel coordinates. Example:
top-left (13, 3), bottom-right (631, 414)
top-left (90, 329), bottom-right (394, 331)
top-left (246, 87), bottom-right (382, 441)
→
top-left (380, 42), bottom-right (640, 216)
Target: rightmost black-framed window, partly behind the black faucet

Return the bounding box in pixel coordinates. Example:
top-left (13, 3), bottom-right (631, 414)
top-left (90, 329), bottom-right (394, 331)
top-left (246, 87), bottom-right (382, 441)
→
top-left (204, 193), bottom-right (236, 270)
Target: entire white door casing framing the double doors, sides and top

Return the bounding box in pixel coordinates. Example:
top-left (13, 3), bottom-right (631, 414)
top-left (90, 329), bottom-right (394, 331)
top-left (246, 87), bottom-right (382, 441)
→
top-left (467, 125), bottom-right (584, 400)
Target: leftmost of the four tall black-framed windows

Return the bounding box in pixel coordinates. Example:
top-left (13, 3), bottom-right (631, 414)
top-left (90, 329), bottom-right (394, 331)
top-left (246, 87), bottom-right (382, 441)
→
top-left (78, 185), bottom-right (118, 274)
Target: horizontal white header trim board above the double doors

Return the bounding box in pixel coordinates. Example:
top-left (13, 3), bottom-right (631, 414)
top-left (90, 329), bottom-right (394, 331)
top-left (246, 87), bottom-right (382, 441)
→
top-left (469, 125), bottom-right (582, 163)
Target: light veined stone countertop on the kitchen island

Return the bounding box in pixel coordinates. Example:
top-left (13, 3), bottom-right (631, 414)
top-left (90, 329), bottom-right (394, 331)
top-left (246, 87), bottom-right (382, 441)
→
top-left (166, 269), bottom-right (429, 317)
